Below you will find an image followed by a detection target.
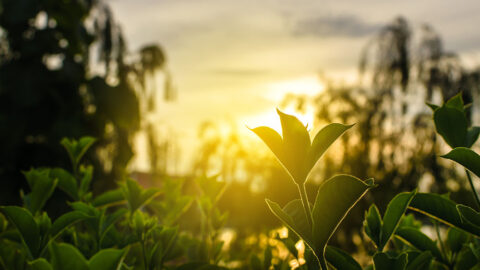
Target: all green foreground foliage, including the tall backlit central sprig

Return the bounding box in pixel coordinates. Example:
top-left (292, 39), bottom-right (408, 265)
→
top-left (4, 95), bottom-right (480, 270)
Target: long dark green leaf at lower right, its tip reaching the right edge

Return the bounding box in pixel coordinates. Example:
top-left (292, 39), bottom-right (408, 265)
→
top-left (409, 193), bottom-right (480, 236)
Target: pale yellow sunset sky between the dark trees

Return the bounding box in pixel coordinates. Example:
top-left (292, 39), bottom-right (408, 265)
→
top-left (107, 0), bottom-right (480, 173)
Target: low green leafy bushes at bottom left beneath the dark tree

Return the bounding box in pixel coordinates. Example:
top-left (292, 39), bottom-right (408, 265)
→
top-left (0, 137), bottom-right (226, 269)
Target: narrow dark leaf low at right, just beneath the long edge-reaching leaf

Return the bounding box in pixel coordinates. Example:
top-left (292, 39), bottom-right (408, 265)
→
top-left (395, 228), bottom-right (444, 261)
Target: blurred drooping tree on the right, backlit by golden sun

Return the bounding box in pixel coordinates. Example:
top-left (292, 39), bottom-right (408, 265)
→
top-left (287, 15), bottom-right (479, 248)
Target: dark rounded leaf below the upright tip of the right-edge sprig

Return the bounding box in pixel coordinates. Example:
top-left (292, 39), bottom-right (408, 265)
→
top-left (433, 106), bottom-right (468, 148)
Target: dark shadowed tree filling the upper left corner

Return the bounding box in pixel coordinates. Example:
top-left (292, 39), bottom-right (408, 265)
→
top-left (0, 0), bottom-right (165, 209)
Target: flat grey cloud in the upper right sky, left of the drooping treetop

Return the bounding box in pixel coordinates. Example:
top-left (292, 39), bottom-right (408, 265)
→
top-left (293, 15), bottom-right (383, 38)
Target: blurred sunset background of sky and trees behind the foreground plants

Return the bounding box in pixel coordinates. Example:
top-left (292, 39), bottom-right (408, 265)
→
top-left (0, 0), bottom-right (480, 256)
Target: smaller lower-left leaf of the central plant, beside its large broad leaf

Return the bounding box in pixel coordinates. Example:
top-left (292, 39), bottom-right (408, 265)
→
top-left (265, 199), bottom-right (313, 247)
